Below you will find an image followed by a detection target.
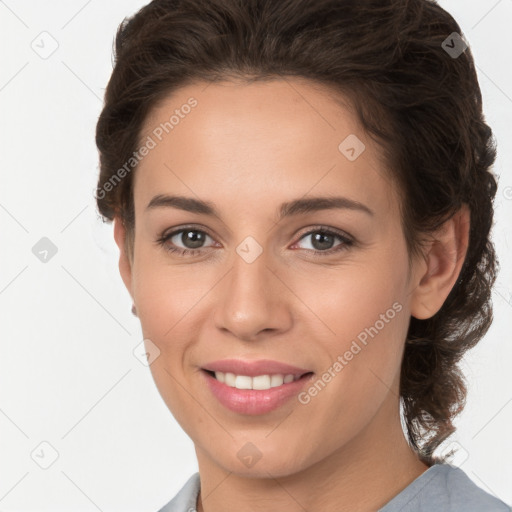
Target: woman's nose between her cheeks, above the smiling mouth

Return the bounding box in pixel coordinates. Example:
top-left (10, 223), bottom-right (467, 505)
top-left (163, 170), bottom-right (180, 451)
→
top-left (215, 245), bottom-right (292, 341)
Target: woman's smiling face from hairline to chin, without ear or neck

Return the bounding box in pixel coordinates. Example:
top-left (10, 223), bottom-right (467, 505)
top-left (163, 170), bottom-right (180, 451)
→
top-left (116, 80), bottom-right (424, 476)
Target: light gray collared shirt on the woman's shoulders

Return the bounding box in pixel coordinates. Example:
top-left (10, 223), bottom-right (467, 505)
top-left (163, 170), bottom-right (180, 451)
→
top-left (159, 464), bottom-right (512, 512)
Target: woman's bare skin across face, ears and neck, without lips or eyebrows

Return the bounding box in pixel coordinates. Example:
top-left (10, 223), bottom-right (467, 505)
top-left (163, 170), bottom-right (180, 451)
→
top-left (114, 79), bottom-right (469, 512)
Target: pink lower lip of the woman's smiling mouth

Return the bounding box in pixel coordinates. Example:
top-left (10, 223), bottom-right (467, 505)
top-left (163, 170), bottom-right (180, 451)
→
top-left (201, 370), bottom-right (313, 415)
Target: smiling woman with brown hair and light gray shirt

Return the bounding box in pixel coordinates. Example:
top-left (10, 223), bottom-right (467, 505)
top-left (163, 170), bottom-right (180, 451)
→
top-left (96, 0), bottom-right (509, 512)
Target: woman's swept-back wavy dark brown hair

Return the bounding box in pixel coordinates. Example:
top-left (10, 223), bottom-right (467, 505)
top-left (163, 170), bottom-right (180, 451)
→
top-left (96, 0), bottom-right (498, 465)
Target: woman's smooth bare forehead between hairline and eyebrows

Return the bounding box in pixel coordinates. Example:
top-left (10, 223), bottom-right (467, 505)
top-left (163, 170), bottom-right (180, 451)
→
top-left (135, 78), bottom-right (393, 216)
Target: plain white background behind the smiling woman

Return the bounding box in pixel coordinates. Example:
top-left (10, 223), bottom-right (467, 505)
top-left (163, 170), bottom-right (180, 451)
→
top-left (0, 0), bottom-right (512, 512)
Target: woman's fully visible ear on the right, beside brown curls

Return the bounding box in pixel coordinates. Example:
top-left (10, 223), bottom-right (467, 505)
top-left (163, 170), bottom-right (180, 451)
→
top-left (411, 205), bottom-right (470, 320)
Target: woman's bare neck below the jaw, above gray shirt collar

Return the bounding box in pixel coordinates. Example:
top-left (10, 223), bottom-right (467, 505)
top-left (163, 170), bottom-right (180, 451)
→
top-left (196, 400), bottom-right (428, 512)
